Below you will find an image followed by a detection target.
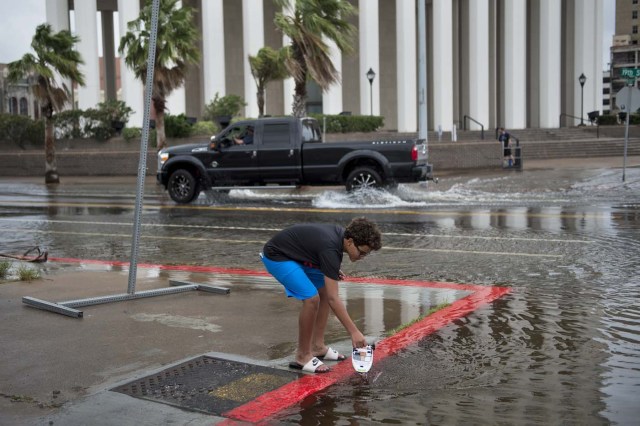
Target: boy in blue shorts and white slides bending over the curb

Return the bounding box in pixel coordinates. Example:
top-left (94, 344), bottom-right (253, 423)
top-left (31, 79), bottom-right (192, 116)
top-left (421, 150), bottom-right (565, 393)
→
top-left (260, 218), bottom-right (382, 373)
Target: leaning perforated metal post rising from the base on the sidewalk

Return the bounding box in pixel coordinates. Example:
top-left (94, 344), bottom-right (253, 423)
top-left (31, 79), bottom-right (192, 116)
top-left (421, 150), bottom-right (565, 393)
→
top-left (127, 0), bottom-right (160, 294)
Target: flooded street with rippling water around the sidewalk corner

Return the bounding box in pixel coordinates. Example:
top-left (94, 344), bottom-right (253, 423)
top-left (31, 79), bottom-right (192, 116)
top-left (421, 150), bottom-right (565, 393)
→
top-left (0, 161), bottom-right (640, 425)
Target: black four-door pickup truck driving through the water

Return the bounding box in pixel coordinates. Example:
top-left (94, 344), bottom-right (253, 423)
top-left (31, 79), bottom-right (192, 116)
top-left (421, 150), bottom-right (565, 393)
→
top-left (157, 117), bottom-right (432, 203)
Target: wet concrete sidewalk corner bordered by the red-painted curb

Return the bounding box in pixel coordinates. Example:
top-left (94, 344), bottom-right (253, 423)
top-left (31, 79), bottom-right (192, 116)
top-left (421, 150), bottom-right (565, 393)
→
top-left (0, 259), bottom-right (470, 426)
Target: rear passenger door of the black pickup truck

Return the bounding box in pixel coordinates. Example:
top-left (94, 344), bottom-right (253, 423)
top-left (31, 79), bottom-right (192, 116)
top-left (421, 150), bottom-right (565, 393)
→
top-left (258, 121), bottom-right (302, 184)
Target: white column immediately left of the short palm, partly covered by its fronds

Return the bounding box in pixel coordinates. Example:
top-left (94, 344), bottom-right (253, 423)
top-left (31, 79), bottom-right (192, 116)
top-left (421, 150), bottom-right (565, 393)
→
top-left (242, 0), bottom-right (264, 117)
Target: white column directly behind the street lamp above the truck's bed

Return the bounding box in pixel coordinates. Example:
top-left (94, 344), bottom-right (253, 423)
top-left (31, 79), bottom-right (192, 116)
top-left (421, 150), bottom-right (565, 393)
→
top-left (358, 0), bottom-right (382, 115)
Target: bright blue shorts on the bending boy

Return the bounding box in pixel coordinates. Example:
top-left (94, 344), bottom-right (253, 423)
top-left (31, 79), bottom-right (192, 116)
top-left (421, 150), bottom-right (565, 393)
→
top-left (260, 253), bottom-right (324, 300)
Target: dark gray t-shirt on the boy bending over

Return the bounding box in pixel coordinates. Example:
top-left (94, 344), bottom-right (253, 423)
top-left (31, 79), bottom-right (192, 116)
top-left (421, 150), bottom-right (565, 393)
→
top-left (263, 223), bottom-right (344, 281)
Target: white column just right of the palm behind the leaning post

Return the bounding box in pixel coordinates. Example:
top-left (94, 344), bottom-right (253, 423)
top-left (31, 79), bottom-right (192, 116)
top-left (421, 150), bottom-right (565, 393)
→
top-left (202, 0), bottom-right (226, 105)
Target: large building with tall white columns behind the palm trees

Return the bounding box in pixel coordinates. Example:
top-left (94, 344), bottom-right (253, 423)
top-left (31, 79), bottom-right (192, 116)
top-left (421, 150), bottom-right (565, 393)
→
top-left (46, 0), bottom-right (603, 132)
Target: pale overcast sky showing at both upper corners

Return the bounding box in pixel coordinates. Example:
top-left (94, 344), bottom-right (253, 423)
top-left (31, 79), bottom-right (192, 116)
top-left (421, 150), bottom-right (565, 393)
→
top-left (0, 0), bottom-right (616, 70)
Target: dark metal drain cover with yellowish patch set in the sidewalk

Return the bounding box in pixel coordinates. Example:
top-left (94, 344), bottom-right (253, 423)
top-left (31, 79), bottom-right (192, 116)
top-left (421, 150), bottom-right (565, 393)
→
top-left (111, 356), bottom-right (302, 416)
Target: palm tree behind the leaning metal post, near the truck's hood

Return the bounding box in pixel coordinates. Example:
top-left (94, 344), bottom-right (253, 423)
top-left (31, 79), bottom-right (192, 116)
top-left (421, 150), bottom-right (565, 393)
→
top-left (118, 0), bottom-right (200, 150)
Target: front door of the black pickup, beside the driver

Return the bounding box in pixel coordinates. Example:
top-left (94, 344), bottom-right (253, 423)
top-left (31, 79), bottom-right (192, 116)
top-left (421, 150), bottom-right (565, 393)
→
top-left (208, 123), bottom-right (260, 186)
